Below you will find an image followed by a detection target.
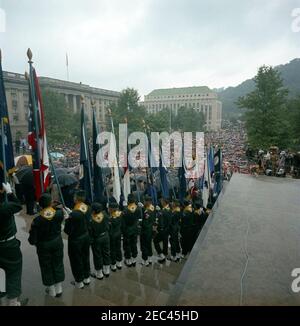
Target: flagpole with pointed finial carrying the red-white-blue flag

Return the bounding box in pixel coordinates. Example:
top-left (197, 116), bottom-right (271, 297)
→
top-left (27, 49), bottom-right (44, 193)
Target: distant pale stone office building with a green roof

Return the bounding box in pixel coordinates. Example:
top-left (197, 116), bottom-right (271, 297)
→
top-left (142, 86), bottom-right (222, 131)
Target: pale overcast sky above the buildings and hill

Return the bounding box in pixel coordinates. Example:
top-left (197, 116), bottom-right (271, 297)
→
top-left (0, 0), bottom-right (300, 95)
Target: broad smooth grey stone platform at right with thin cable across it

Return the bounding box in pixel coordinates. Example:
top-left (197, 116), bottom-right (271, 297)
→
top-left (168, 175), bottom-right (300, 305)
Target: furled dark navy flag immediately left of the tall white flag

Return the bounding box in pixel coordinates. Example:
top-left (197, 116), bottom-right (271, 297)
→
top-left (93, 111), bottom-right (104, 202)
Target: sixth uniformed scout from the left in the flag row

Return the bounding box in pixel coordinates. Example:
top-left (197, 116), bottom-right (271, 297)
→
top-left (122, 195), bottom-right (141, 267)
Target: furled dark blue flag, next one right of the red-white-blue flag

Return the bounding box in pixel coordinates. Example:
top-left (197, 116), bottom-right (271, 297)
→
top-left (79, 103), bottom-right (93, 203)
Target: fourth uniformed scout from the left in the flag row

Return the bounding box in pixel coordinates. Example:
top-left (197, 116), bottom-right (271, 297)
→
top-left (89, 203), bottom-right (110, 280)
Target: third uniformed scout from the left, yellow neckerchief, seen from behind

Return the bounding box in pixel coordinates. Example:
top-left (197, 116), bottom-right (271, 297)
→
top-left (64, 191), bottom-right (91, 289)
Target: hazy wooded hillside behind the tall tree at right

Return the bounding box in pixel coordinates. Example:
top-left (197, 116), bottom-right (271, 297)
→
top-left (218, 58), bottom-right (300, 117)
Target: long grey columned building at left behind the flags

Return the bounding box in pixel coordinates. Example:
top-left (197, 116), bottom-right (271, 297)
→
top-left (3, 72), bottom-right (120, 140)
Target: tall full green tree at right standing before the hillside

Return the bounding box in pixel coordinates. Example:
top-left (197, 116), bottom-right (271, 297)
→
top-left (237, 66), bottom-right (290, 149)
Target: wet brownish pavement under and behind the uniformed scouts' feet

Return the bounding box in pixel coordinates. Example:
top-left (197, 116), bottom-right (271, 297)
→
top-left (0, 209), bottom-right (184, 306)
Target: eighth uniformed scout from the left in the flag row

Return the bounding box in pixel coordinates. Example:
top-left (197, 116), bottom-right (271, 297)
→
top-left (154, 199), bottom-right (172, 263)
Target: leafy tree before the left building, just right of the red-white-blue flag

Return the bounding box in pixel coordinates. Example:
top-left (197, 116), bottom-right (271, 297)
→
top-left (42, 89), bottom-right (80, 144)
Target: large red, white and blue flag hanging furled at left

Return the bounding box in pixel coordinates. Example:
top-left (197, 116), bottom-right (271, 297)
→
top-left (28, 63), bottom-right (51, 200)
